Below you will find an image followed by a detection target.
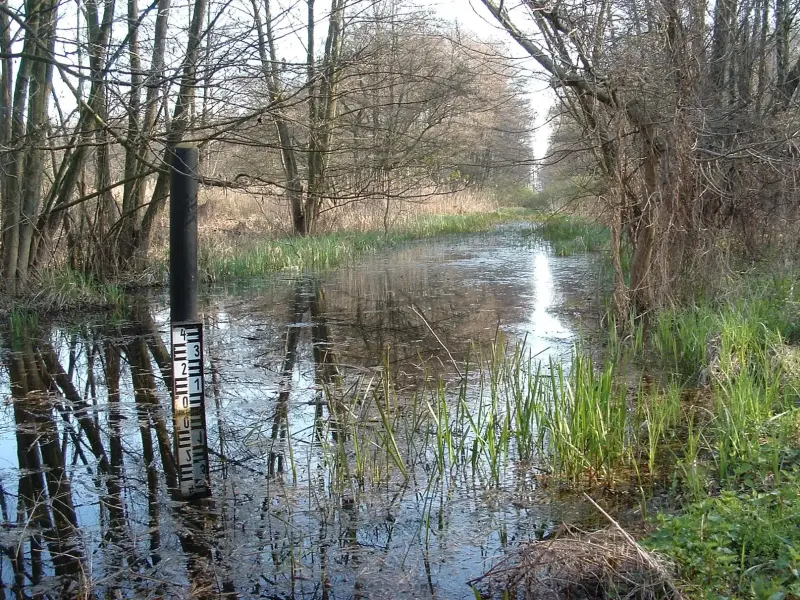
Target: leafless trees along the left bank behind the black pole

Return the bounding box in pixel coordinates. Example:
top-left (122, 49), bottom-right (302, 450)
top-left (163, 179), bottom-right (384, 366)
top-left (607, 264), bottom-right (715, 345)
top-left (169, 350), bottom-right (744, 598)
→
top-left (0, 0), bottom-right (531, 293)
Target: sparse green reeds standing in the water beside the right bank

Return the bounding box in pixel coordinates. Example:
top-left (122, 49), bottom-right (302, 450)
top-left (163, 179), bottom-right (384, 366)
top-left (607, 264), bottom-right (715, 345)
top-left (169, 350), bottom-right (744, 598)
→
top-left (314, 342), bottom-right (679, 488)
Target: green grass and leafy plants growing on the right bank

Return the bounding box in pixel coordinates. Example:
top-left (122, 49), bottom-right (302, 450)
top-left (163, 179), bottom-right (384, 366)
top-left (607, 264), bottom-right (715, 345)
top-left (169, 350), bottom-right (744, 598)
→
top-left (647, 273), bottom-right (800, 600)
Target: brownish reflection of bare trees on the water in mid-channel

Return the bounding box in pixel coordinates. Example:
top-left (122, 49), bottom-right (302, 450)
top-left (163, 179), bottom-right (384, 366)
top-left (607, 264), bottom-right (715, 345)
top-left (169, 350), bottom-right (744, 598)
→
top-left (328, 258), bottom-right (523, 388)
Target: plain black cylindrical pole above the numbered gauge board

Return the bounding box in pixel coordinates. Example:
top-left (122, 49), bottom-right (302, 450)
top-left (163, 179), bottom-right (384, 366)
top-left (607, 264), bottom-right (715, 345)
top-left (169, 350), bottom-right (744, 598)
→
top-left (169, 145), bottom-right (200, 322)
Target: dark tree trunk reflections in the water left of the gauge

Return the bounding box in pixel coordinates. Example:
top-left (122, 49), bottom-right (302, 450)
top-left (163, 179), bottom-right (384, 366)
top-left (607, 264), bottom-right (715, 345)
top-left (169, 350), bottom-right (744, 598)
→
top-left (0, 303), bottom-right (233, 598)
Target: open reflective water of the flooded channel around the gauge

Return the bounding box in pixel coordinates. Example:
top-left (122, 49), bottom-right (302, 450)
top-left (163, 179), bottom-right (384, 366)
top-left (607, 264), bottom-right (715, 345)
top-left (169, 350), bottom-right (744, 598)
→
top-left (0, 228), bottom-right (596, 599)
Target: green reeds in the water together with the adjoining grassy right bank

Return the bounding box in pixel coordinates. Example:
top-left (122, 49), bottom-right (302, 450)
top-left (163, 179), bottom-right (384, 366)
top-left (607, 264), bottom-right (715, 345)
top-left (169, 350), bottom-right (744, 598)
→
top-left (310, 254), bottom-right (800, 600)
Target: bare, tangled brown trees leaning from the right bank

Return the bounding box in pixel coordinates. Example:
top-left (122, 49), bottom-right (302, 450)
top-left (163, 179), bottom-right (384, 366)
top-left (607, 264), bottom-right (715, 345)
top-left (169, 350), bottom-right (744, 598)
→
top-left (483, 0), bottom-right (800, 315)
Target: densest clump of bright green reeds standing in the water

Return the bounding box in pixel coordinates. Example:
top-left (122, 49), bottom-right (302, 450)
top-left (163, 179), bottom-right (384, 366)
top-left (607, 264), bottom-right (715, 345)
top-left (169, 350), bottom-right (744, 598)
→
top-left (450, 343), bottom-right (681, 486)
